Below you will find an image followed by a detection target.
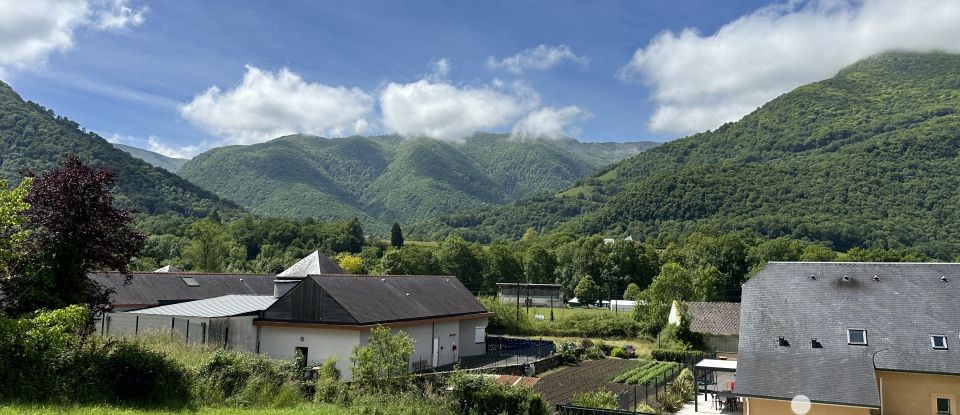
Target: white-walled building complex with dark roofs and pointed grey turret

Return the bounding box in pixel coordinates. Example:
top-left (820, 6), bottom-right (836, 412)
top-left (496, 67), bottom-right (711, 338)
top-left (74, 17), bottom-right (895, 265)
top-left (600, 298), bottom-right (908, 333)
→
top-left (98, 253), bottom-right (491, 379)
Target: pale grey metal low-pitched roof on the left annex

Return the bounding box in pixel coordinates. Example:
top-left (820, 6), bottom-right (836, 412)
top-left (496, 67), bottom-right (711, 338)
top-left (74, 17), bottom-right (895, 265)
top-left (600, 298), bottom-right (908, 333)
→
top-left (131, 295), bottom-right (277, 317)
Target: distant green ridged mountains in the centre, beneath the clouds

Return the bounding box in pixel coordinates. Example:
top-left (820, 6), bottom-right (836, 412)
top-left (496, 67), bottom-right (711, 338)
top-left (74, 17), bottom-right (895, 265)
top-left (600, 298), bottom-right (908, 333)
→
top-left (179, 134), bottom-right (655, 231)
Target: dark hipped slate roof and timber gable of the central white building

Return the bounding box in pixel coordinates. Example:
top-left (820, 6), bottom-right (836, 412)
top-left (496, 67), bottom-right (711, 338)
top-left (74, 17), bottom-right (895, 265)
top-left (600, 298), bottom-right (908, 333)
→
top-left (264, 275), bottom-right (487, 325)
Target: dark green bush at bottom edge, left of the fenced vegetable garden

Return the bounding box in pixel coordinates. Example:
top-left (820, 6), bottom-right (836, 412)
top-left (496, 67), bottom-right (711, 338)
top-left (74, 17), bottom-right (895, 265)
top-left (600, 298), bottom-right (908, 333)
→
top-left (450, 373), bottom-right (551, 415)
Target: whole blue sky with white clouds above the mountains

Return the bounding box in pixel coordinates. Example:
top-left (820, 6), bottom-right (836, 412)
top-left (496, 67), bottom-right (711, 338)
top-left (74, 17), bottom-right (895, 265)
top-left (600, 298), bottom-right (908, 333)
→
top-left (0, 0), bottom-right (960, 157)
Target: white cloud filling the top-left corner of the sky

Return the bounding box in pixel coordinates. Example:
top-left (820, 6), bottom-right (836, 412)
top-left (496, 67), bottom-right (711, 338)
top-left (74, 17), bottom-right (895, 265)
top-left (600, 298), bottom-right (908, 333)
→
top-left (0, 0), bottom-right (147, 73)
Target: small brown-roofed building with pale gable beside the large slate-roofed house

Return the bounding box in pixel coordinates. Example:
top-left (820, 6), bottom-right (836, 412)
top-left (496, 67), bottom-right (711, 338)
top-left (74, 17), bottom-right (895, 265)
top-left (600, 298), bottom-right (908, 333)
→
top-left (668, 301), bottom-right (740, 358)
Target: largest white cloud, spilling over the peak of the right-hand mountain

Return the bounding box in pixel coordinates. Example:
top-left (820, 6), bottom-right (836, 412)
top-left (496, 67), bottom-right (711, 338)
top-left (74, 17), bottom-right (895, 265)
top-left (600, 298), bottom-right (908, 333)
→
top-left (620, 0), bottom-right (960, 134)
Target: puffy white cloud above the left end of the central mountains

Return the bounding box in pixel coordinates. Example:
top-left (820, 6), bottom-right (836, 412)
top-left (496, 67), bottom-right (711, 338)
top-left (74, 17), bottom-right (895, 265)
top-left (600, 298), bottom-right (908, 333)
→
top-left (180, 66), bottom-right (373, 144)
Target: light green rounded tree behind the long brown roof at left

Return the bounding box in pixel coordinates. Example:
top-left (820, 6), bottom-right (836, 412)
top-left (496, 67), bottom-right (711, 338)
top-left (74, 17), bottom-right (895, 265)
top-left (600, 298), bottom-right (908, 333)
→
top-left (183, 219), bottom-right (238, 272)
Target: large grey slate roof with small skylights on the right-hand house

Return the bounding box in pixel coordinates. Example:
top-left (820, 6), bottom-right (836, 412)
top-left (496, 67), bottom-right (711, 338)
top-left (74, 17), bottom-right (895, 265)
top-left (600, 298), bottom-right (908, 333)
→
top-left (737, 262), bottom-right (960, 407)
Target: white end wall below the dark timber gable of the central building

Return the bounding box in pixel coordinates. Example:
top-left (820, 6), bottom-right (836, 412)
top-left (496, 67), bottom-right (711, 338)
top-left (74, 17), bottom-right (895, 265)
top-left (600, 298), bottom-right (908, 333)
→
top-left (260, 326), bottom-right (361, 380)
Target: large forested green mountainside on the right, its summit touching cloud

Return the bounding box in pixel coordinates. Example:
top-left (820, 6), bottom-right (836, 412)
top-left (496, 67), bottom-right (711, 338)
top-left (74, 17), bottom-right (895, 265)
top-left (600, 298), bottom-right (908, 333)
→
top-left (411, 53), bottom-right (960, 254)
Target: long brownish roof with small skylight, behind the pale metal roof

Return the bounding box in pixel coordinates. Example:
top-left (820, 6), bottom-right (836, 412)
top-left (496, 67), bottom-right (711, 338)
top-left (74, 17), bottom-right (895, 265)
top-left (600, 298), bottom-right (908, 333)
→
top-left (88, 272), bottom-right (274, 307)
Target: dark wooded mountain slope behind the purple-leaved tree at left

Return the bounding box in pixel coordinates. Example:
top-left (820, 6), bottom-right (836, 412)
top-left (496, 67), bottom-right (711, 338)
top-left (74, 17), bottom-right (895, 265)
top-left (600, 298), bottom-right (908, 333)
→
top-left (0, 82), bottom-right (237, 216)
